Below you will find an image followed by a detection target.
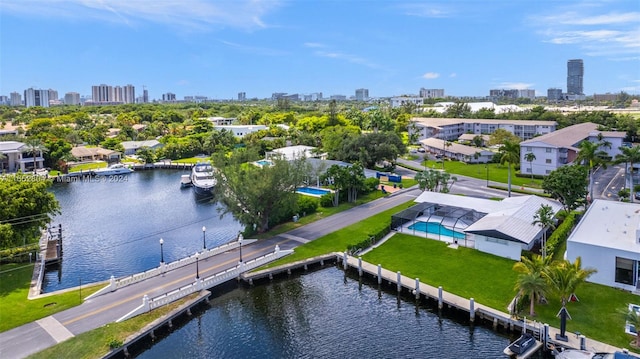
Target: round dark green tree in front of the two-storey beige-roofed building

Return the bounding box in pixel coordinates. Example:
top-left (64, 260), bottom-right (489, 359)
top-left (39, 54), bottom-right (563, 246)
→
top-left (542, 165), bottom-right (588, 212)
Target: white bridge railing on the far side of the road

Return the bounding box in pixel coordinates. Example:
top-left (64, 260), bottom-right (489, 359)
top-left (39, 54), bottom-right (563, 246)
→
top-left (86, 239), bottom-right (257, 299)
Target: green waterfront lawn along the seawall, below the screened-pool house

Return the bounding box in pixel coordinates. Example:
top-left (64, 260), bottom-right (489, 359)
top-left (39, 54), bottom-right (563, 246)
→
top-left (363, 234), bottom-right (640, 348)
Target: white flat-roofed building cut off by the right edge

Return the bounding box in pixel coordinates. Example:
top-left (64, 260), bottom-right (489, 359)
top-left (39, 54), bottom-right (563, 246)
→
top-left (566, 199), bottom-right (640, 291)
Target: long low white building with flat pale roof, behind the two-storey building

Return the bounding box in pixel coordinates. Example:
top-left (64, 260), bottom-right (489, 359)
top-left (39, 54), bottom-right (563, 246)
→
top-left (408, 117), bottom-right (557, 141)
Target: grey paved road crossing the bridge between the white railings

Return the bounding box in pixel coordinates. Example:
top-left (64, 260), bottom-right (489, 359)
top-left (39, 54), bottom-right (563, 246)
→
top-left (0, 189), bottom-right (419, 358)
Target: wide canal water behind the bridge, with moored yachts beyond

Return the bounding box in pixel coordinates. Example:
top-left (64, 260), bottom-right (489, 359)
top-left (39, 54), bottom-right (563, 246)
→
top-left (43, 170), bottom-right (241, 292)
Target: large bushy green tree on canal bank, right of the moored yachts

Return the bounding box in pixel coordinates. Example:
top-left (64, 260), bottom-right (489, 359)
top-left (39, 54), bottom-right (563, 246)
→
top-left (214, 150), bottom-right (309, 233)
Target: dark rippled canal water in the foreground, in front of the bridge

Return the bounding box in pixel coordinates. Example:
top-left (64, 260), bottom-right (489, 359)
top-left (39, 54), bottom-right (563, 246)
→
top-left (132, 267), bottom-right (536, 359)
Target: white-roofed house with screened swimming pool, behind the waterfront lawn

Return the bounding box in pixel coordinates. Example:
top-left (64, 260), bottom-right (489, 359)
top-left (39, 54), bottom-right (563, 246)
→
top-left (398, 191), bottom-right (562, 260)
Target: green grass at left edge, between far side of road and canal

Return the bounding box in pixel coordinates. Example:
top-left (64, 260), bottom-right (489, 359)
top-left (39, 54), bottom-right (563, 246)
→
top-left (0, 263), bottom-right (103, 332)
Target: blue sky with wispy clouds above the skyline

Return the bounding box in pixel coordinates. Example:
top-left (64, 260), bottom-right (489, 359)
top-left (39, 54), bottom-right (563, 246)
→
top-left (0, 0), bottom-right (640, 99)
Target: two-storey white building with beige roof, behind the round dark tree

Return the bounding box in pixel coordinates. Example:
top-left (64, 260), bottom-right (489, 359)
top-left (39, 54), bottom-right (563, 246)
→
top-left (520, 122), bottom-right (626, 175)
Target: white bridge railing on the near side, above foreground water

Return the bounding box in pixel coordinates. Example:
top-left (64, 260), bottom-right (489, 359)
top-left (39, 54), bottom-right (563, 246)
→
top-left (116, 245), bottom-right (293, 322)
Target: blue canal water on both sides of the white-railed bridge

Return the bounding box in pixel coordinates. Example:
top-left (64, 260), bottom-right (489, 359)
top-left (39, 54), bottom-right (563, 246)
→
top-left (45, 170), bottom-right (536, 359)
